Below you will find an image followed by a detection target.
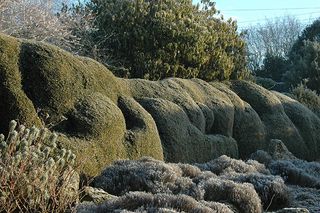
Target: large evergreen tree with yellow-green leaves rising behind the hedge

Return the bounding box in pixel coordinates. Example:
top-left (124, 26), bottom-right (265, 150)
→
top-left (89, 0), bottom-right (246, 81)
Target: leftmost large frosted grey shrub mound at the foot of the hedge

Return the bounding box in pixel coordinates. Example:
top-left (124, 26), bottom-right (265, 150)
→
top-left (94, 157), bottom-right (202, 199)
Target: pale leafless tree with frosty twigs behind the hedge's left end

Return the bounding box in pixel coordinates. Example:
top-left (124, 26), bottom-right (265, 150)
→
top-left (0, 0), bottom-right (92, 50)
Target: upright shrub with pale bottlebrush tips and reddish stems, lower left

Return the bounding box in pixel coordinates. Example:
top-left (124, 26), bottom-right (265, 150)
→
top-left (0, 121), bottom-right (79, 212)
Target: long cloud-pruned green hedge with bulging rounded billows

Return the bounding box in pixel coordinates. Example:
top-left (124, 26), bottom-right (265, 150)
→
top-left (0, 35), bottom-right (320, 175)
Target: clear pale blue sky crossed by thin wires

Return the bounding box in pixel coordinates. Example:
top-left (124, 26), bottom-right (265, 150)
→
top-left (193, 0), bottom-right (320, 29)
